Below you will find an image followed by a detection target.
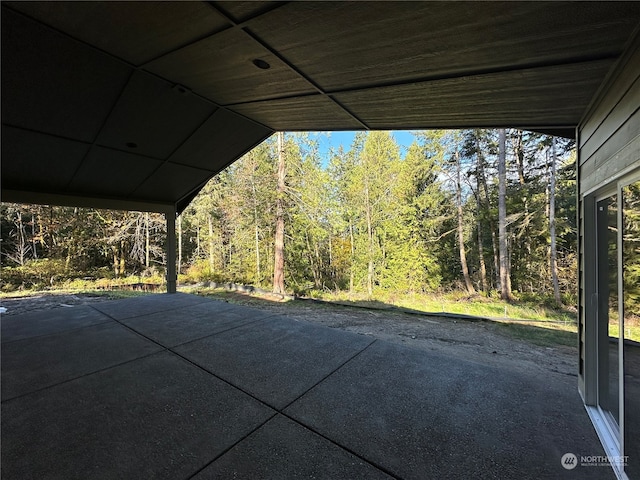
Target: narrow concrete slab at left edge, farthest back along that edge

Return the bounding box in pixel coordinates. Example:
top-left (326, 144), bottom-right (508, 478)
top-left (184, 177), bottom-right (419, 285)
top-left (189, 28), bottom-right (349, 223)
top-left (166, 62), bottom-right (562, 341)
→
top-left (0, 305), bottom-right (112, 343)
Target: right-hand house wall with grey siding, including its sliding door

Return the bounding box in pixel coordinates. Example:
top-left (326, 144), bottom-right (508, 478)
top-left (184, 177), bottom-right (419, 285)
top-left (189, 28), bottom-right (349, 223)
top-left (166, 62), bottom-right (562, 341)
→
top-left (576, 31), bottom-right (640, 480)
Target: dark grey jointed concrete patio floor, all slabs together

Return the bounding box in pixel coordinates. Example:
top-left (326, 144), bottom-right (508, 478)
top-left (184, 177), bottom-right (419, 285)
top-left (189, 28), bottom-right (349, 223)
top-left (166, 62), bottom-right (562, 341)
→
top-left (2, 293), bottom-right (615, 479)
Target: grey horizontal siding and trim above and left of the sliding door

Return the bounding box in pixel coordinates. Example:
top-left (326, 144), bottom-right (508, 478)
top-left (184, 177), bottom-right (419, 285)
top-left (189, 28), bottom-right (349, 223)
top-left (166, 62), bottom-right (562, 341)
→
top-left (577, 34), bottom-right (640, 405)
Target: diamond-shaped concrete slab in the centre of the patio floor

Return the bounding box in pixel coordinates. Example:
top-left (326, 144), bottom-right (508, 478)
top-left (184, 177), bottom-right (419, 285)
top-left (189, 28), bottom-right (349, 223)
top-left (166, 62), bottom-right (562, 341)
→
top-left (175, 317), bottom-right (373, 409)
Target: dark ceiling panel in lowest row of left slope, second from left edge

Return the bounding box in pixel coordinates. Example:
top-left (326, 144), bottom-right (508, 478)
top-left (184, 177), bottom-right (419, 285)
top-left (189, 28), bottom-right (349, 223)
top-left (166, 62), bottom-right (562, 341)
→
top-left (69, 147), bottom-right (162, 200)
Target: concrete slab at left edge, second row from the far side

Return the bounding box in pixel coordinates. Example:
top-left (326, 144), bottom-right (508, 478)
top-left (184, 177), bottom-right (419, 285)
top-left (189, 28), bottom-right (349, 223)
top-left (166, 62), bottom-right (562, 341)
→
top-left (2, 322), bottom-right (163, 401)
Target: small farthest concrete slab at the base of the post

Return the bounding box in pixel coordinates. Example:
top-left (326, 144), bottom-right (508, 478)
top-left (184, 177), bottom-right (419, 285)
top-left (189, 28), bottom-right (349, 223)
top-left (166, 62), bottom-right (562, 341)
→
top-left (93, 293), bottom-right (214, 320)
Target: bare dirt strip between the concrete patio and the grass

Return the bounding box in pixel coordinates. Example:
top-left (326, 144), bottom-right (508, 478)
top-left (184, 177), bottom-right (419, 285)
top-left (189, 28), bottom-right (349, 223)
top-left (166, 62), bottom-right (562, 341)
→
top-left (0, 293), bottom-right (577, 377)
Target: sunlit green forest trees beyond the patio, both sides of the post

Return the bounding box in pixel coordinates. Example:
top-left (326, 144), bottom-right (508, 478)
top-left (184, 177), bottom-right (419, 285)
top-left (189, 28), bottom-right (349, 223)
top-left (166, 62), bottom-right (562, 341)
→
top-left (0, 129), bottom-right (577, 304)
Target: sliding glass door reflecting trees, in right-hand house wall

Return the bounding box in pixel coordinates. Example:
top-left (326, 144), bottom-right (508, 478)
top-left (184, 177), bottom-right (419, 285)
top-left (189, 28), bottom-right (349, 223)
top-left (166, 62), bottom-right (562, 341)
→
top-left (595, 174), bottom-right (640, 478)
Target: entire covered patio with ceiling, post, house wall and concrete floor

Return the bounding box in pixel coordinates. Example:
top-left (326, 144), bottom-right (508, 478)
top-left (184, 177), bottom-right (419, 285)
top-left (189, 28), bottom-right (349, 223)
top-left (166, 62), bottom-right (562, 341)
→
top-left (1, 1), bottom-right (640, 479)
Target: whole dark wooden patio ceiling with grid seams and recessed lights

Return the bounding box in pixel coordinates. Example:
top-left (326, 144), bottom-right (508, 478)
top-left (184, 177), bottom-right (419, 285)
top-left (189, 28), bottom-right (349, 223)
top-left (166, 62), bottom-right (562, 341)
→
top-left (2, 1), bottom-right (640, 210)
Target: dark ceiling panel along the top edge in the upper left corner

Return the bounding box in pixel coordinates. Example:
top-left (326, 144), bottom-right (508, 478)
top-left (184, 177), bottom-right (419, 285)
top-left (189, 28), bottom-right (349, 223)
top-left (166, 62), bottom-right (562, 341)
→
top-left (3, 1), bottom-right (230, 65)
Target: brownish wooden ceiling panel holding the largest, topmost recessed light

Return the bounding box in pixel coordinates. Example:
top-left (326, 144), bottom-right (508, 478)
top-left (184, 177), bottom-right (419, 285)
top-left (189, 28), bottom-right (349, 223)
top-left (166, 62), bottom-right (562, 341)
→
top-left (145, 30), bottom-right (314, 105)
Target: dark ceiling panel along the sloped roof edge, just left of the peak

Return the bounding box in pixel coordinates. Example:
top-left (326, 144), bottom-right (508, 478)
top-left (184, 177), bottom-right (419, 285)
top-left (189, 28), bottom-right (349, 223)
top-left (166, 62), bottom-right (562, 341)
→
top-left (169, 109), bottom-right (272, 173)
